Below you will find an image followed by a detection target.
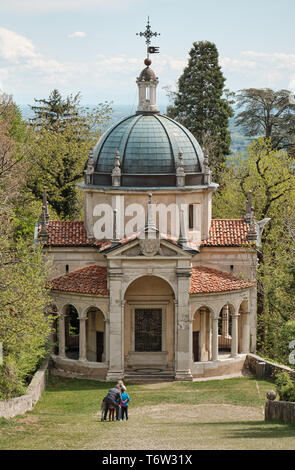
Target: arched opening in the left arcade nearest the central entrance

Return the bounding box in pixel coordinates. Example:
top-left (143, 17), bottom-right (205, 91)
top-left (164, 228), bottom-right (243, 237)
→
top-left (86, 307), bottom-right (106, 362)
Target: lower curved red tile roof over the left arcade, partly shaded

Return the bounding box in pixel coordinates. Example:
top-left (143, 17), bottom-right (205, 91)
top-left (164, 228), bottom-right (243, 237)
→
top-left (51, 265), bottom-right (109, 295)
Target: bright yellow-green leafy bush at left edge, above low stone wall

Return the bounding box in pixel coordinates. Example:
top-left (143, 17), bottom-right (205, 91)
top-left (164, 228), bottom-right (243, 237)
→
top-left (0, 235), bottom-right (52, 399)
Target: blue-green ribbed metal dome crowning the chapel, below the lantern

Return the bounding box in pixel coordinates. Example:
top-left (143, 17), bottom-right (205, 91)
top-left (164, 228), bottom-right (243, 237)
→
top-left (93, 113), bottom-right (203, 175)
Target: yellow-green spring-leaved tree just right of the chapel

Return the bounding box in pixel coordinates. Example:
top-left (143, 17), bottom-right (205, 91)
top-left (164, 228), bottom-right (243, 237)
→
top-left (213, 138), bottom-right (295, 357)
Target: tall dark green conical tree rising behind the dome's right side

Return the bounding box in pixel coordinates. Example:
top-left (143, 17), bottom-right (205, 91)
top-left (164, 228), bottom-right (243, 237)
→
top-left (167, 41), bottom-right (233, 182)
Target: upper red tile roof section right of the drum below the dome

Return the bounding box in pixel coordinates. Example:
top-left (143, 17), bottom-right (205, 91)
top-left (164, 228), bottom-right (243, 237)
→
top-left (201, 219), bottom-right (249, 246)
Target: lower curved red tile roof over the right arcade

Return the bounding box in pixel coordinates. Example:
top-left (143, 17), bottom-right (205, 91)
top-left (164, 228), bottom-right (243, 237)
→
top-left (190, 266), bottom-right (255, 294)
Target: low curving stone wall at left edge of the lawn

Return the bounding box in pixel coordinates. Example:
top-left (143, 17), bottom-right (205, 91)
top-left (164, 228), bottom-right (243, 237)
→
top-left (0, 359), bottom-right (49, 419)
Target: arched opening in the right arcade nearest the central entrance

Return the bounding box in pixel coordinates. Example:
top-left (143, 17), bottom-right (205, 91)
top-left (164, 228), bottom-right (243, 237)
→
top-left (192, 307), bottom-right (211, 362)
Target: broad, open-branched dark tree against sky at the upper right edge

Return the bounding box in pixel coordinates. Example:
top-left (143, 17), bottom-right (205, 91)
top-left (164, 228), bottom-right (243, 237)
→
top-left (235, 88), bottom-right (295, 156)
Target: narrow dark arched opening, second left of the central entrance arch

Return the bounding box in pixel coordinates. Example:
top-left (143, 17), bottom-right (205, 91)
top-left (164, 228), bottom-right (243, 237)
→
top-left (64, 304), bottom-right (80, 359)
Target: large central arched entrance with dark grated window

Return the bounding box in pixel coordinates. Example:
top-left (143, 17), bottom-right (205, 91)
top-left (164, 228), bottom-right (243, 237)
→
top-left (124, 276), bottom-right (175, 370)
